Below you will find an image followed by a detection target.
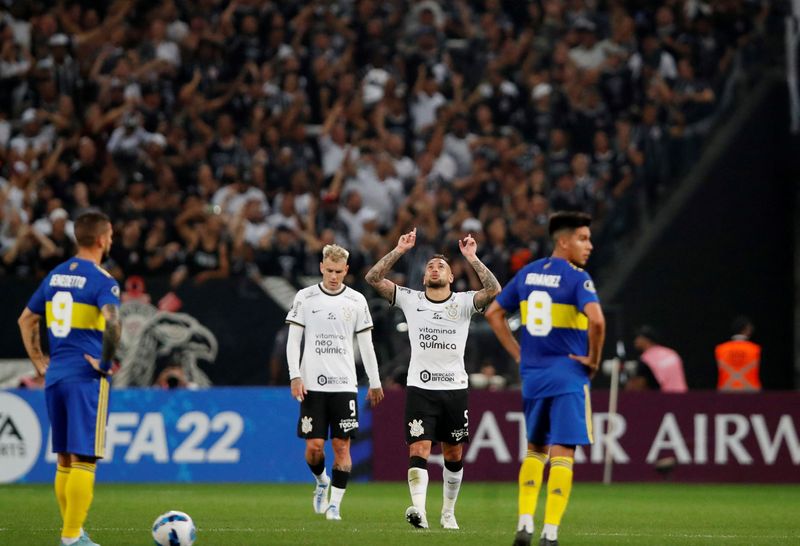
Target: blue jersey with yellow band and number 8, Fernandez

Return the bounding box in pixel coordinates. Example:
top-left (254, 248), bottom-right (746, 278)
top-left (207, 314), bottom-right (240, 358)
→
top-left (497, 257), bottom-right (598, 398)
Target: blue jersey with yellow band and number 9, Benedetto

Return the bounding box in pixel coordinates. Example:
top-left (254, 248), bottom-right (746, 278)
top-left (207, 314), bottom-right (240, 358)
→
top-left (28, 257), bottom-right (119, 385)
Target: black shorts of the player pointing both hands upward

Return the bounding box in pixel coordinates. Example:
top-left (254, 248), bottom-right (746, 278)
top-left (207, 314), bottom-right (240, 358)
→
top-left (404, 387), bottom-right (469, 444)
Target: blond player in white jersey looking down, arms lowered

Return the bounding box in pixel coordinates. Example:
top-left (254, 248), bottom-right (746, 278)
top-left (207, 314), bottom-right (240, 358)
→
top-left (286, 245), bottom-right (383, 520)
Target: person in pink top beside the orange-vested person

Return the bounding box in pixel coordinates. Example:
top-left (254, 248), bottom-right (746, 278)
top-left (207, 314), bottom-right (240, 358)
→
top-left (625, 325), bottom-right (688, 393)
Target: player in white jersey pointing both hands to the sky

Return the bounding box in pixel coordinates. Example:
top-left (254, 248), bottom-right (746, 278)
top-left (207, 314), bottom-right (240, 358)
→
top-left (366, 228), bottom-right (500, 529)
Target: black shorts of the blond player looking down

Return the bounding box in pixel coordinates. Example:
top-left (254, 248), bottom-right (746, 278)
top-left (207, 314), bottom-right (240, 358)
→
top-left (297, 391), bottom-right (358, 440)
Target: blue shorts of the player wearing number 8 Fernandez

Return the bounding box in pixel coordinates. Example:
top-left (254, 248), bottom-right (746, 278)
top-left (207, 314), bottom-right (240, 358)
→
top-left (523, 386), bottom-right (594, 446)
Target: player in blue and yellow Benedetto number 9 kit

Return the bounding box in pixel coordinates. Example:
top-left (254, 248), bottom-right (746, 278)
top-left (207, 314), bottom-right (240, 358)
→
top-left (18, 212), bottom-right (120, 546)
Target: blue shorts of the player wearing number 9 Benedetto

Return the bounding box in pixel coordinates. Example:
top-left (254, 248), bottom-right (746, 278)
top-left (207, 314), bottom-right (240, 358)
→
top-left (44, 377), bottom-right (109, 459)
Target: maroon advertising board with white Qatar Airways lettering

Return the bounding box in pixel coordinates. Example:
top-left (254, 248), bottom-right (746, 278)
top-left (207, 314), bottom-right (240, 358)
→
top-left (373, 391), bottom-right (800, 482)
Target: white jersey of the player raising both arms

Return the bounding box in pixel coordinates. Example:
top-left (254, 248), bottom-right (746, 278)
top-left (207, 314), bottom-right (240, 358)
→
top-left (394, 286), bottom-right (478, 390)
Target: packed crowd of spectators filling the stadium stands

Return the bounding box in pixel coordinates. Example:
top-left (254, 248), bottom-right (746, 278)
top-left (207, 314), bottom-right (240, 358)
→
top-left (0, 0), bottom-right (769, 289)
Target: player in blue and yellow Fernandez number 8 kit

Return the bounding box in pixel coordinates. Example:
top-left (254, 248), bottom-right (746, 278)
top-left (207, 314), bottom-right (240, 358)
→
top-left (486, 212), bottom-right (605, 546)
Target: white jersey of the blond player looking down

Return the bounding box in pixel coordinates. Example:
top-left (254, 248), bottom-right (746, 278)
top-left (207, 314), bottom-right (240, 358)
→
top-left (286, 284), bottom-right (372, 392)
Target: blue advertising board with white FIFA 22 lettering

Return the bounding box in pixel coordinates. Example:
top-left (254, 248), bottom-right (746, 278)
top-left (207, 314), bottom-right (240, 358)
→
top-left (0, 387), bottom-right (370, 483)
